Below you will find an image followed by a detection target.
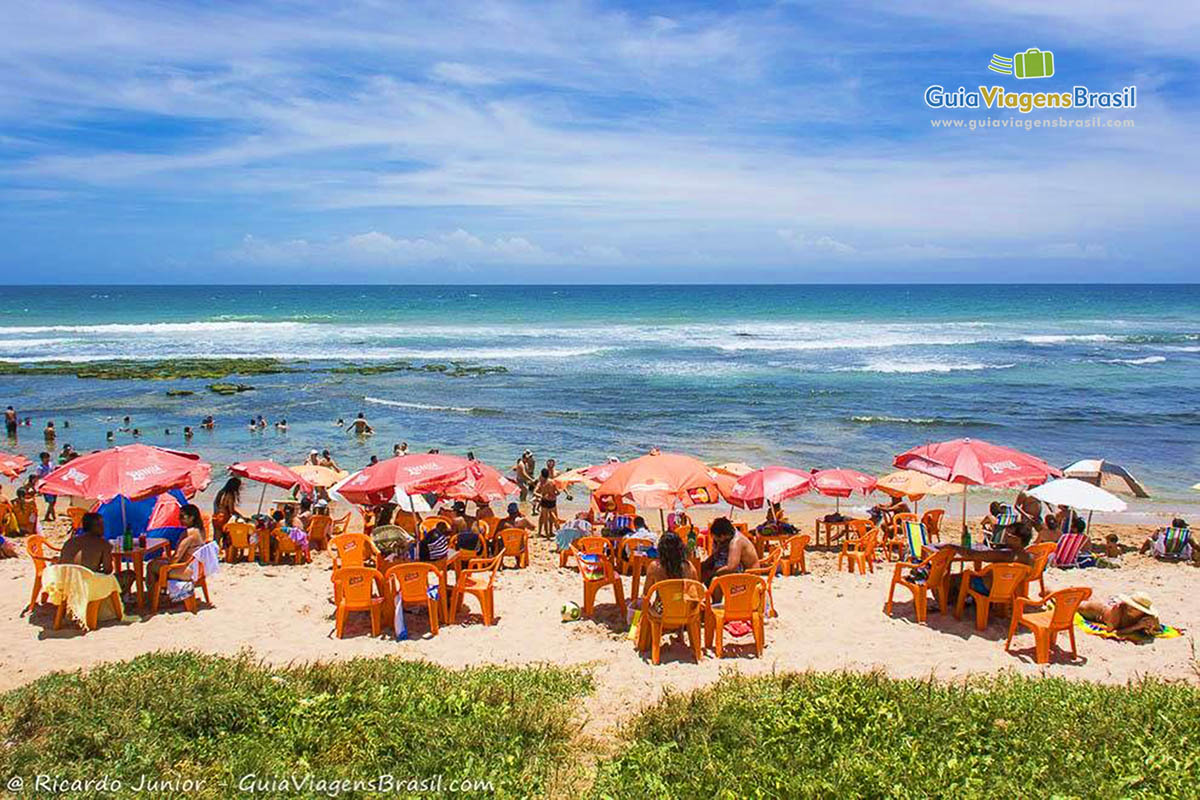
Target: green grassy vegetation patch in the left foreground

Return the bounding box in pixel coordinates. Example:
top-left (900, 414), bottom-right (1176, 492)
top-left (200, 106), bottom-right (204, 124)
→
top-left (0, 652), bottom-right (590, 798)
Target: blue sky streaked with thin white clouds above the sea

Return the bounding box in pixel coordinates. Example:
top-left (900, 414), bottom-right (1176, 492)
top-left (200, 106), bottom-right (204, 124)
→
top-left (0, 0), bottom-right (1200, 283)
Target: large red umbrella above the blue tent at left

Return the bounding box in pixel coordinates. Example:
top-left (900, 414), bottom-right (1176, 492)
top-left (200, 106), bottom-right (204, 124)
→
top-left (37, 445), bottom-right (212, 503)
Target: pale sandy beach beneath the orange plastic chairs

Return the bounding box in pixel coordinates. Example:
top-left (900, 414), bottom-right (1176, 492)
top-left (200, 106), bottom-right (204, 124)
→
top-left (0, 507), bottom-right (1200, 729)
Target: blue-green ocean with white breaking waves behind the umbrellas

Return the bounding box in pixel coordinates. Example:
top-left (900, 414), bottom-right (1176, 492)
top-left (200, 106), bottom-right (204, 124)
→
top-left (0, 286), bottom-right (1200, 511)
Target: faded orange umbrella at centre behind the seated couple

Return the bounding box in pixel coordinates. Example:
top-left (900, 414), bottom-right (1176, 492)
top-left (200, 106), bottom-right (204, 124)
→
top-left (595, 452), bottom-right (721, 520)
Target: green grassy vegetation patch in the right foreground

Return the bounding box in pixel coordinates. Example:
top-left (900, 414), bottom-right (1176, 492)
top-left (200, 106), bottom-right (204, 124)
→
top-left (595, 674), bottom-right (1200, 798)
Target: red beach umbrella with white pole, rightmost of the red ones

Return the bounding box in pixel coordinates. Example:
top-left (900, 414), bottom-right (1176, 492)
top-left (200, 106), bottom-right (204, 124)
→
top-left (893, 439), bottom-right (1062, 530)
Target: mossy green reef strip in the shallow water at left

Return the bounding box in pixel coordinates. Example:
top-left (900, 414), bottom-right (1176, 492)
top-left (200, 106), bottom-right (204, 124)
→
top-left (0, 359), bottom-right (294, 380)
